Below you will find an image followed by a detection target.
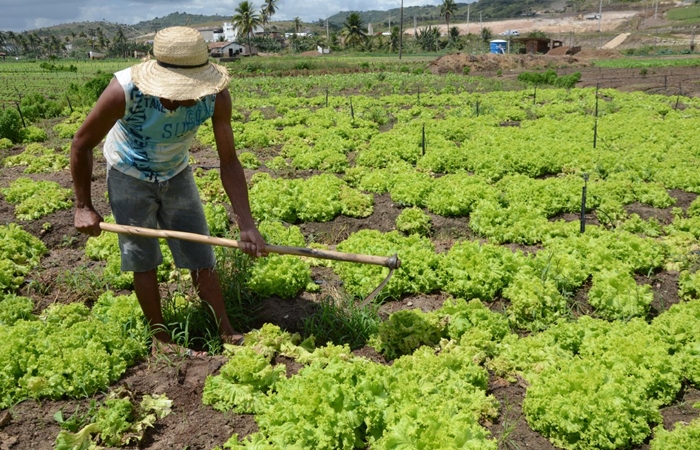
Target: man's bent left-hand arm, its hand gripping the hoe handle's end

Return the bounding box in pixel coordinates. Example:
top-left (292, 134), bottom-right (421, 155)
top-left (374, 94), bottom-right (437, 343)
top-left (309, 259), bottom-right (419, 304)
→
top-left (70, 79), bottom-right (126, 236)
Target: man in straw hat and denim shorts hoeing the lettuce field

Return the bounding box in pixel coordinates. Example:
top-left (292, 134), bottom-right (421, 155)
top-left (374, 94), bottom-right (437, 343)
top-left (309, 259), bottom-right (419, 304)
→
top-left (70, 27), bottom-right (265, 354)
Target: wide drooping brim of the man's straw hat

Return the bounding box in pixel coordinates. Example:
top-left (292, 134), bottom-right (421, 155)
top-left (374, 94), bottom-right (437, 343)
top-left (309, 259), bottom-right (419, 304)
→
top-left (131, 60), bottom-right (230, 101)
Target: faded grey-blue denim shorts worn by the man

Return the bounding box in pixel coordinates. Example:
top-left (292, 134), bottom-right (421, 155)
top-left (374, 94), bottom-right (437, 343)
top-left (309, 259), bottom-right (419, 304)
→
top-left (107, 167), bottom-right (216, 272)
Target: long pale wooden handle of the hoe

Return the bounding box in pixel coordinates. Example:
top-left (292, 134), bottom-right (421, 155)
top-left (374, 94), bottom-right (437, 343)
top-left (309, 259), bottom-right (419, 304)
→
top-left (100, 222), bottom-right (401, 270)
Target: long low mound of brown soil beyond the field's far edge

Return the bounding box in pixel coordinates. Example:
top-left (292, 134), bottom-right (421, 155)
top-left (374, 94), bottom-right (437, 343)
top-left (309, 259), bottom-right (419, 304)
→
top-left (428, 53), bottom-right (590, 75)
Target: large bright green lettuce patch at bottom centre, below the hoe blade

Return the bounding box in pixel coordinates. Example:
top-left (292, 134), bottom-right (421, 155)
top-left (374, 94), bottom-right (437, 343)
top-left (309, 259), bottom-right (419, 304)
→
top-left (212, 327), bottom-right (497, 450)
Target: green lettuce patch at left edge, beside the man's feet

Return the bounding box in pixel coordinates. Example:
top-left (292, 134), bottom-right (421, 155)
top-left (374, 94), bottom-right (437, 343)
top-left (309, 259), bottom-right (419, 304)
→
top-left (0, 292), bottom-right (147, 408)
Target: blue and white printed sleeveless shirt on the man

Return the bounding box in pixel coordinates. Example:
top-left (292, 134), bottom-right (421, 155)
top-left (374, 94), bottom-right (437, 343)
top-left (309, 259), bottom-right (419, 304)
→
top-left (103, 68), bottom-right (216, 182)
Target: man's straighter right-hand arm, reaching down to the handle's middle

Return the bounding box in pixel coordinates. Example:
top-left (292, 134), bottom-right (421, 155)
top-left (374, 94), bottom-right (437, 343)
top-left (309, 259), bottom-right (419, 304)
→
top-left (212, 89), bottom-right (266, 256)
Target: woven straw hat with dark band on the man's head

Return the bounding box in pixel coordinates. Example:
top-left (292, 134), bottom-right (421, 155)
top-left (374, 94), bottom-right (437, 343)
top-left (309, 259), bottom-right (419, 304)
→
top-left (131, 27), bottom-right (229, 100)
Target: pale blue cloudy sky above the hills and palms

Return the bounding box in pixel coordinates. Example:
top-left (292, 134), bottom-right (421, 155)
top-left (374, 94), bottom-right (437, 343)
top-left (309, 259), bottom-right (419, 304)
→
top-left (0, 0), bottom-right (442, 32)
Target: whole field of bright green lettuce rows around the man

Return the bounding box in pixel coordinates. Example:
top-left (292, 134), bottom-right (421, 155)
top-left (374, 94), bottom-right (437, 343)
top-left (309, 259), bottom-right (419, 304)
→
top-left (0, 60), bottom-right (700, 450)
